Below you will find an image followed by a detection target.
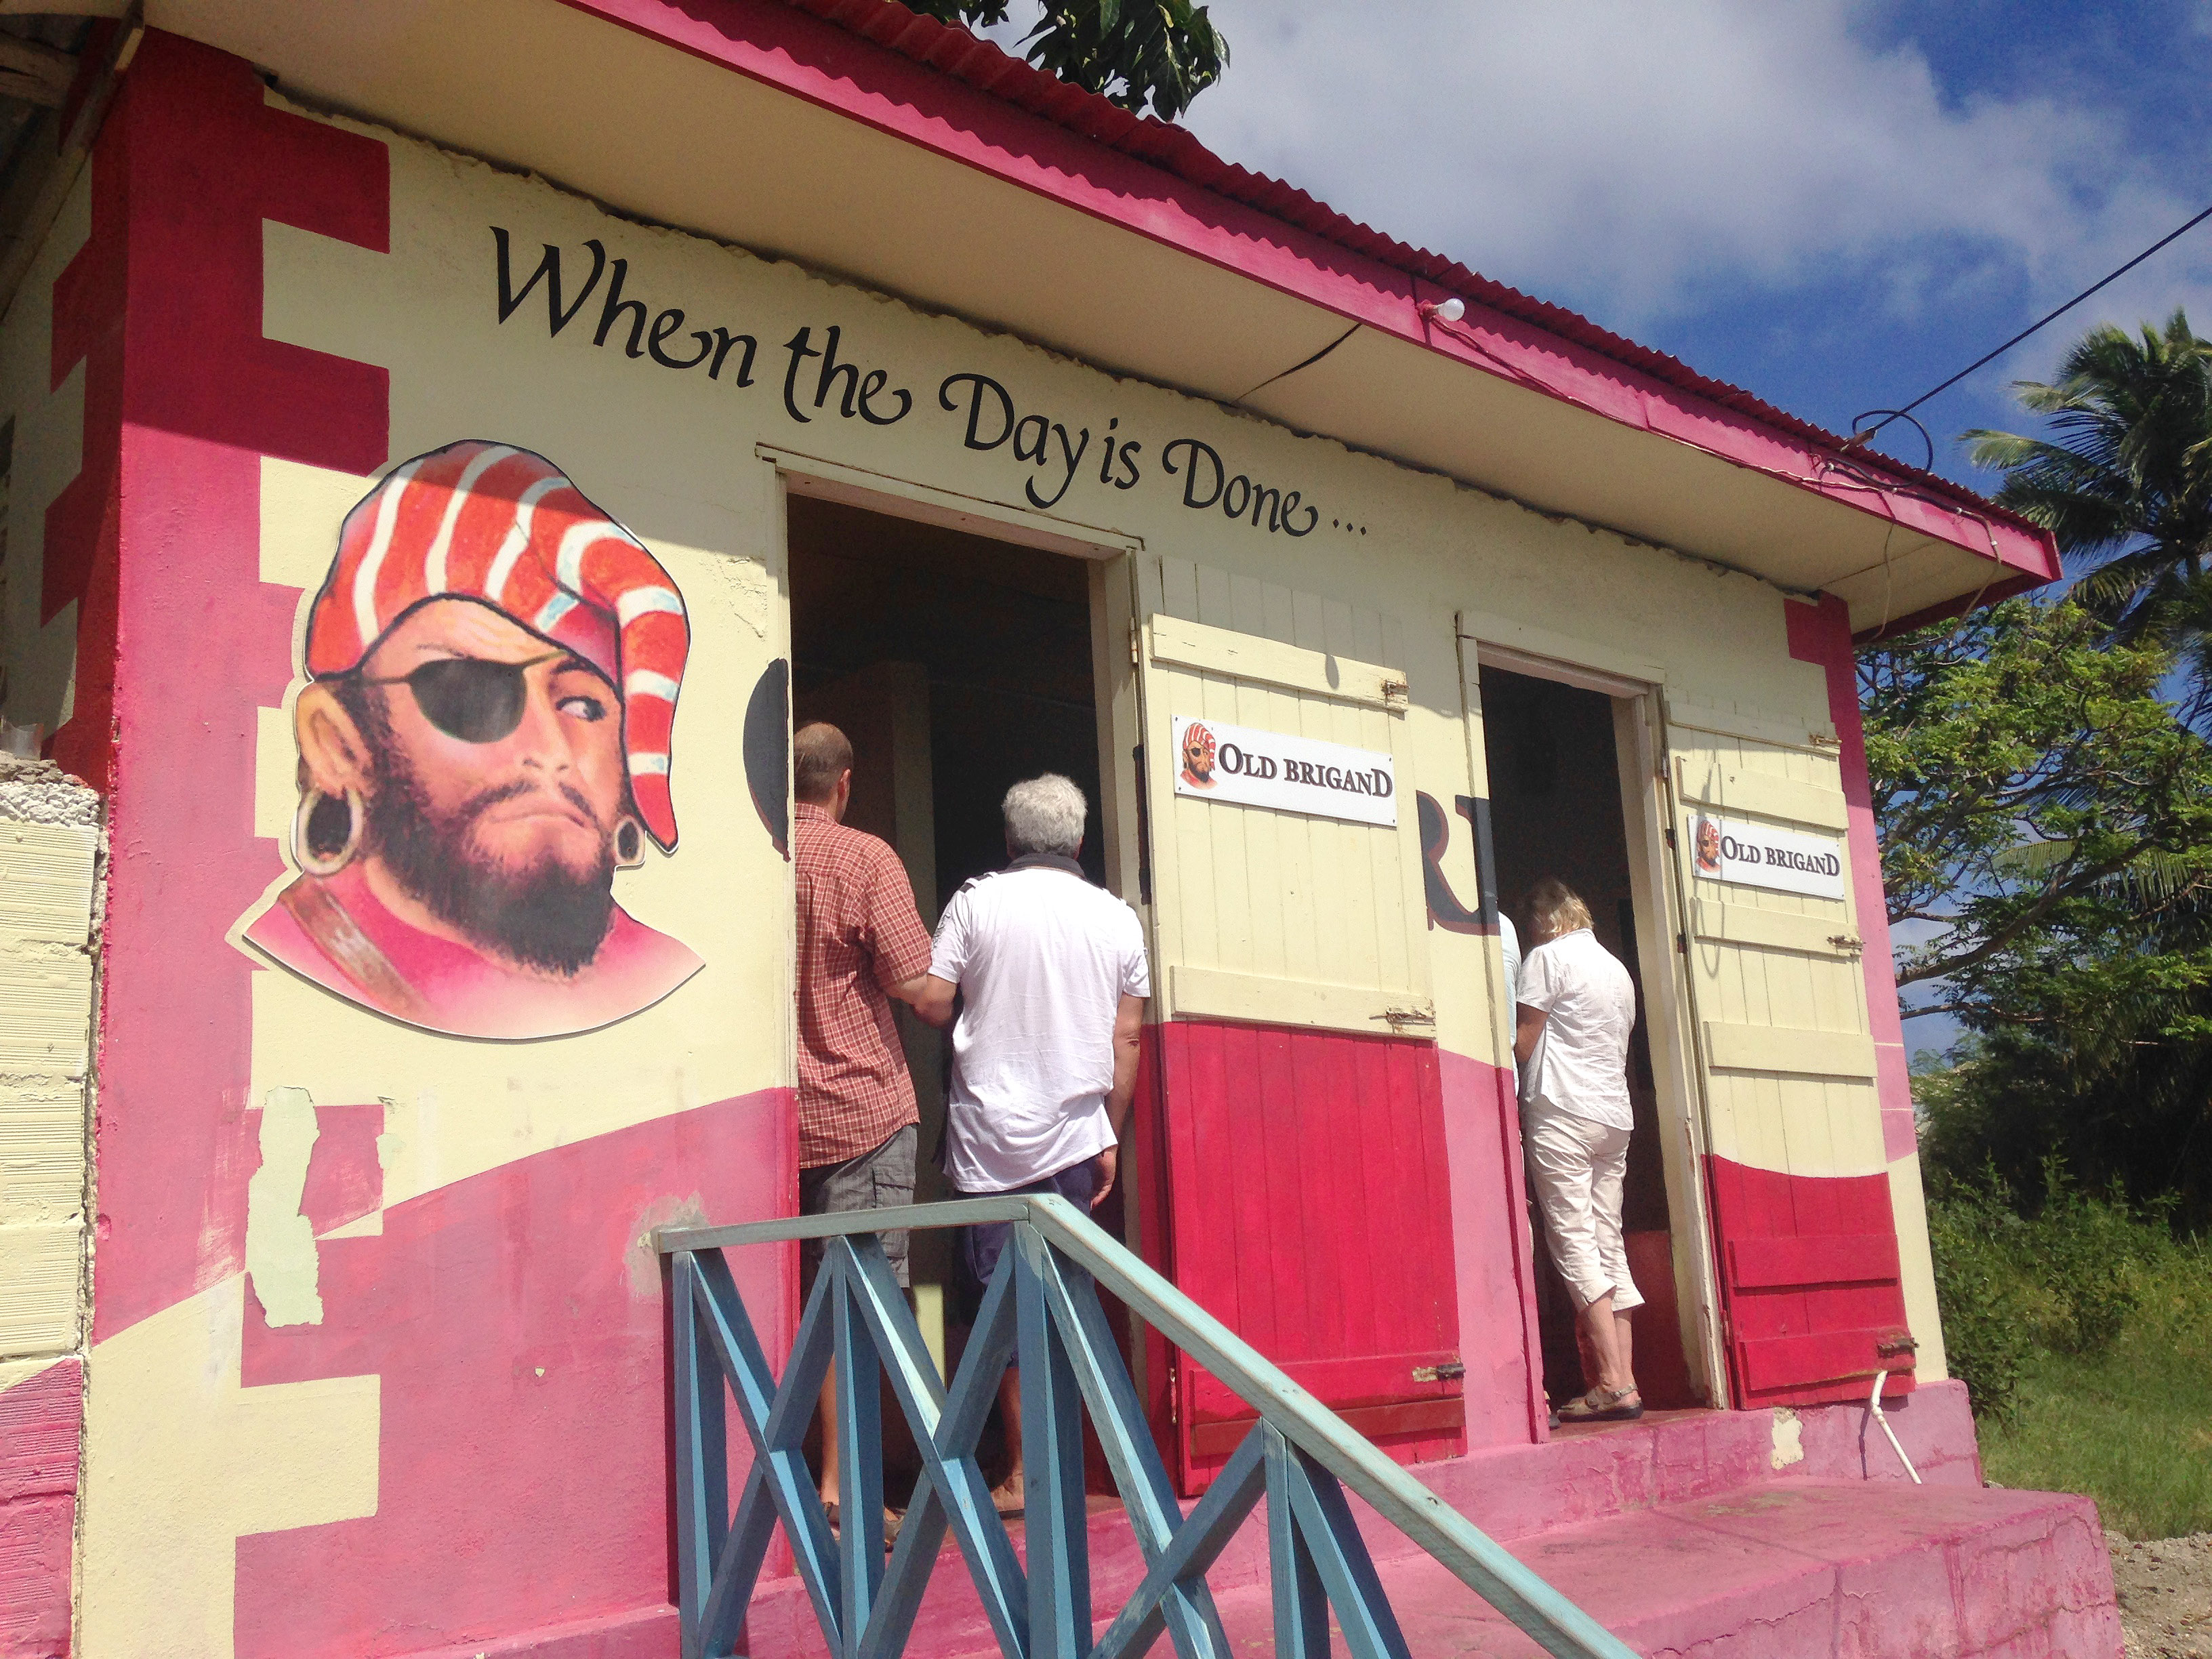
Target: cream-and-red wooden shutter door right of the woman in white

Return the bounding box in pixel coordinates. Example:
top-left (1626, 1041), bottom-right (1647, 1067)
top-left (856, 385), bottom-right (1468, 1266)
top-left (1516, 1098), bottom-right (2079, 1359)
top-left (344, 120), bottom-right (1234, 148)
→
top-left (1668, 701), bottom-right (1913, 1407)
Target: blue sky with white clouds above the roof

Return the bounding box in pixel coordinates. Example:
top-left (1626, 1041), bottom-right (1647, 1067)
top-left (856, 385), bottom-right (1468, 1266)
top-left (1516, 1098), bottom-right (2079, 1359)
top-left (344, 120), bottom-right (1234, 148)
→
top-left (991, 0), bottom-right (2212, 483)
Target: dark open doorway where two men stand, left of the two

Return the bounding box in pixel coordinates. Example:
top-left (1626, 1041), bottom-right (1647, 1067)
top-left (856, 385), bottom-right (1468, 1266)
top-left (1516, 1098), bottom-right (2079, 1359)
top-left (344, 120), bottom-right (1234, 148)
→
top-left (787, 495), bottom-right (1120, 1374)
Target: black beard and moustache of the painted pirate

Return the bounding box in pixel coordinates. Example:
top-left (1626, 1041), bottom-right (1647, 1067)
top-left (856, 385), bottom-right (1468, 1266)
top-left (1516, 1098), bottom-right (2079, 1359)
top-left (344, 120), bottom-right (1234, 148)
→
top-left (365, 703), bottom-right (615, 975)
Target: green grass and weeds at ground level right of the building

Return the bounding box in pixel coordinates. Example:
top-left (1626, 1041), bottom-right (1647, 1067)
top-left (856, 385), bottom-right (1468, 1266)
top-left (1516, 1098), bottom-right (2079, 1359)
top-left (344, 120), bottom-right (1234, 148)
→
top-left (1931, 1188), bottom-right (2212, 1537)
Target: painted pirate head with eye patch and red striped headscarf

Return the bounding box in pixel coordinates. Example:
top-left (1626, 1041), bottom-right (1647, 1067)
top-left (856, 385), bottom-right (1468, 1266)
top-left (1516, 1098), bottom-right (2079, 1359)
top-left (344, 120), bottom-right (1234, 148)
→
top-left (245, 443), bottom-right (701, 1038)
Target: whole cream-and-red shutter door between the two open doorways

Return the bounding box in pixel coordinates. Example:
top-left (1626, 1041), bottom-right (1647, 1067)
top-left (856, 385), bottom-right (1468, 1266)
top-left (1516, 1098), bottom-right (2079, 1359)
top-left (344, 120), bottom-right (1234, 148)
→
top-left (1137, 560), bottom-right (1465, 1491)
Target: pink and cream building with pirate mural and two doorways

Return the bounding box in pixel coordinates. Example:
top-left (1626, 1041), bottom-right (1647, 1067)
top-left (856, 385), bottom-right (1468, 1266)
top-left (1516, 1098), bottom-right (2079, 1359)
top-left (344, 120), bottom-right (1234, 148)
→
top-left (0, 0), bottom-right (2117, 1659)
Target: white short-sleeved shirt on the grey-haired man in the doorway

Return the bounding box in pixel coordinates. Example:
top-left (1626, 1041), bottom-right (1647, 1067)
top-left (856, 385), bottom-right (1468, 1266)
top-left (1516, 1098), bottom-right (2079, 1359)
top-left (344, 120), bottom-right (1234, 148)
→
top-left (929, 865), bottom-right (1153, 1192)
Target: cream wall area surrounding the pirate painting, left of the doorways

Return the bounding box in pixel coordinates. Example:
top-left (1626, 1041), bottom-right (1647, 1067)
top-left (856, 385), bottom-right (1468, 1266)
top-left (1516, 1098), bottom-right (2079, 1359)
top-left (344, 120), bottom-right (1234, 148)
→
top-left (241, 100), bottom-right (790, 1204)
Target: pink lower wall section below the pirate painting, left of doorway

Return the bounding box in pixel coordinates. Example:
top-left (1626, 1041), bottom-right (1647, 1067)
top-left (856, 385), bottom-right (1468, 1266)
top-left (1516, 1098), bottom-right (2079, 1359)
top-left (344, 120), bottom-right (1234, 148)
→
top-left (237, 1090), bottom-right (794, 1659)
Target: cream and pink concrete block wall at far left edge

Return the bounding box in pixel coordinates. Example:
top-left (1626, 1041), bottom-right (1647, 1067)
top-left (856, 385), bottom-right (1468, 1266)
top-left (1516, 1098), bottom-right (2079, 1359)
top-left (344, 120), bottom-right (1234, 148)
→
top-left (0, 756), bottom-right (102, 1659)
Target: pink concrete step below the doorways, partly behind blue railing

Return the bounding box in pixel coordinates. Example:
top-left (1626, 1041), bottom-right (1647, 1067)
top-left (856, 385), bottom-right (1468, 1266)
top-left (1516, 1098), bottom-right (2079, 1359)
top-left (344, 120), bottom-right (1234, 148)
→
top-left (747, 1385), bottom-right (2121, 1659)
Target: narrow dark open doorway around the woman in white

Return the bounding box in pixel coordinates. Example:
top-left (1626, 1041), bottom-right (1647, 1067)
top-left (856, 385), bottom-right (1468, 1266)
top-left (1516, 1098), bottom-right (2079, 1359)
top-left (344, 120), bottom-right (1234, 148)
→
top-left (1480, 661), bottom-right (1703, 1409)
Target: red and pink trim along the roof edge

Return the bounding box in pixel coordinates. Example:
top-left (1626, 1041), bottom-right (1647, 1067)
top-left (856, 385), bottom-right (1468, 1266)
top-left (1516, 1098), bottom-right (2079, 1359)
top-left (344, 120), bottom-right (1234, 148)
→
top-left (548, 0), bottom-right (2060, 588)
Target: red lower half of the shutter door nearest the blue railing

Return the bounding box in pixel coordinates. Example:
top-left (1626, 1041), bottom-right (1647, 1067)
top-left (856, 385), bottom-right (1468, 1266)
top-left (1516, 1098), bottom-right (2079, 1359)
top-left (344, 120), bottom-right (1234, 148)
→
top-left (1150, 1020), bottom-right (1465, 1491)
